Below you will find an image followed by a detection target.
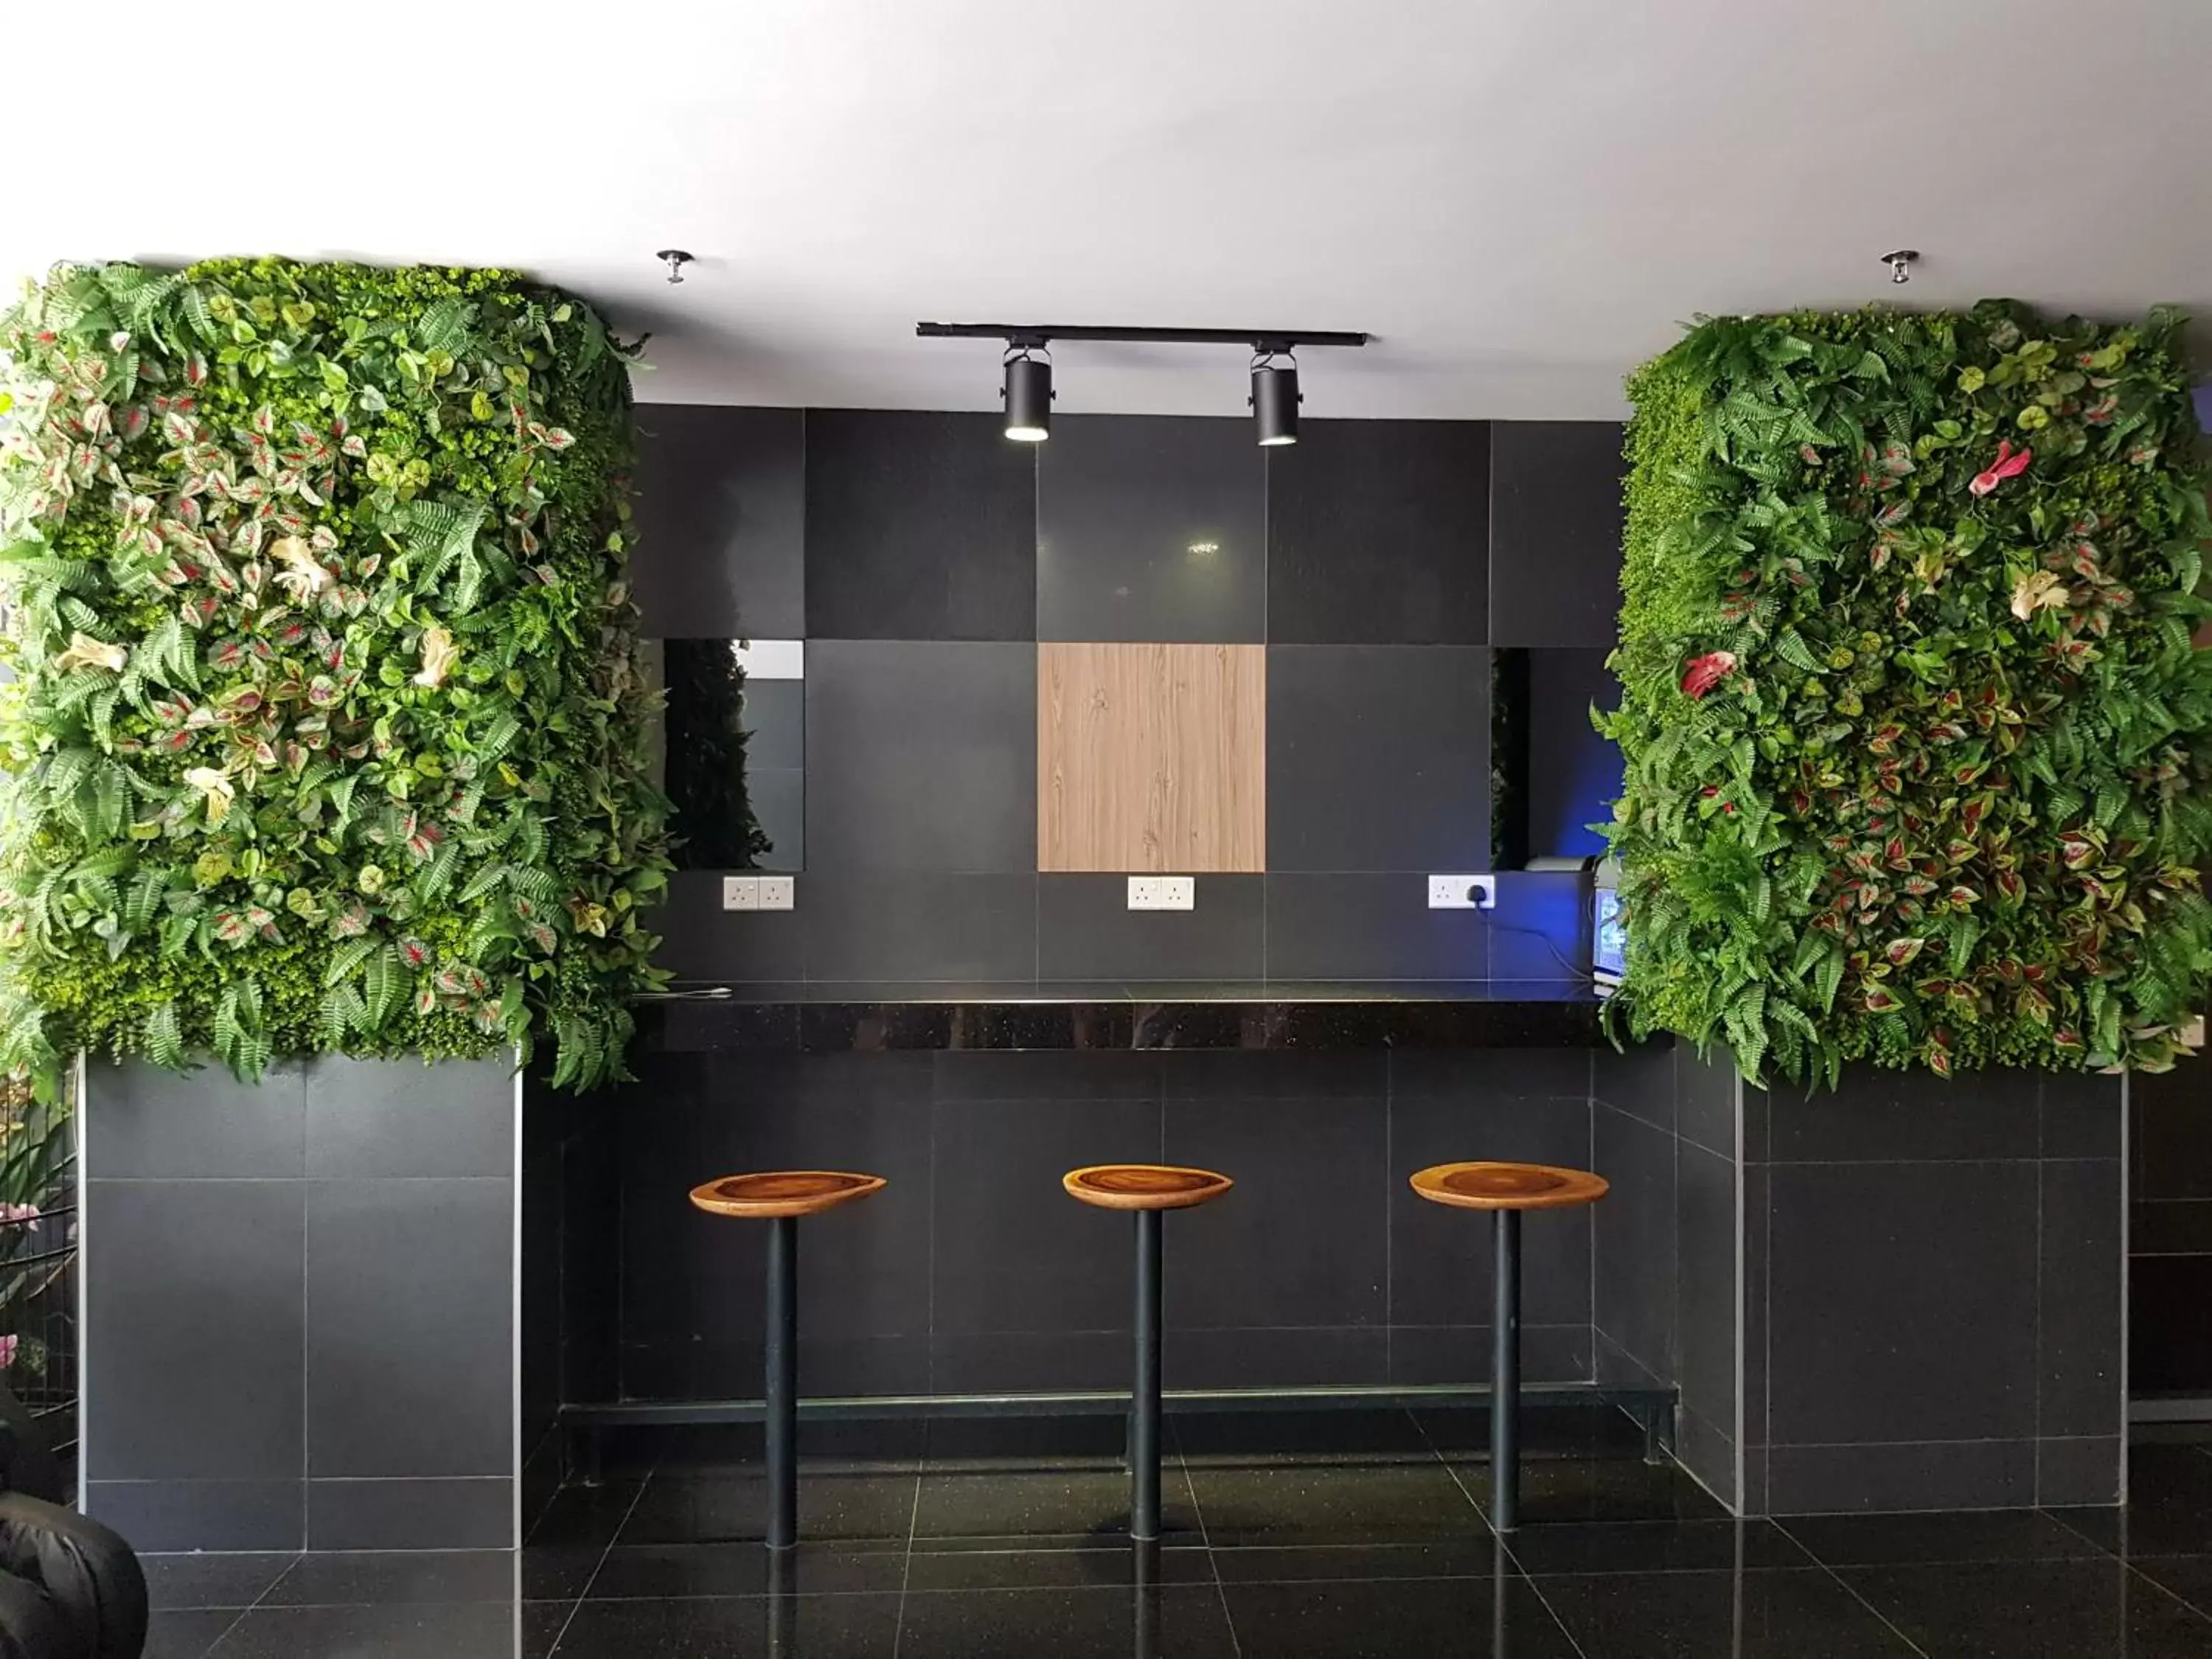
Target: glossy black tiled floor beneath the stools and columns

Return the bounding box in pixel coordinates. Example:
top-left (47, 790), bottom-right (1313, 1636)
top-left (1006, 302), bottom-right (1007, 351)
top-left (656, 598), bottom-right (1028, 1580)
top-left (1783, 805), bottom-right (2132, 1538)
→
top-left (133, 1413), bottom-right (2212, 1659)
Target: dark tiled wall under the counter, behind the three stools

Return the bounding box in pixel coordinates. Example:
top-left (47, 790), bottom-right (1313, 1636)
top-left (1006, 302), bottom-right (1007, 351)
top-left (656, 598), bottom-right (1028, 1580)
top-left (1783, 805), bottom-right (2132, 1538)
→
top-left (597, 1051), bottom-right (1604, 1398)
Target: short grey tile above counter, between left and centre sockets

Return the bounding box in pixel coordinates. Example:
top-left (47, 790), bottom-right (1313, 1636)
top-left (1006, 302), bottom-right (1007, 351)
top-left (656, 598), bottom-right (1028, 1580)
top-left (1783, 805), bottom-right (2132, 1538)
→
top-left (799, 872), bottom-right (1037, 980)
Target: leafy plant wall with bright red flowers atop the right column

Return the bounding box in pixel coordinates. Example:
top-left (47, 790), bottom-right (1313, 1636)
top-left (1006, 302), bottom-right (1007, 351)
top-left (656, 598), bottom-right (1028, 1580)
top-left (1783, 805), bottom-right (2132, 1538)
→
top-left (1599, 301), bottom-right (2212, 1079)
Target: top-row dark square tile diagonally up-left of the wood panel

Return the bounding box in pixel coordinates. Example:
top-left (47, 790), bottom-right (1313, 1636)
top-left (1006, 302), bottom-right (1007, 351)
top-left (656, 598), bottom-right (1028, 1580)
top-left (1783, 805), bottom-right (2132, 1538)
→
top-left (794, 409), bottom-right (1035, 641)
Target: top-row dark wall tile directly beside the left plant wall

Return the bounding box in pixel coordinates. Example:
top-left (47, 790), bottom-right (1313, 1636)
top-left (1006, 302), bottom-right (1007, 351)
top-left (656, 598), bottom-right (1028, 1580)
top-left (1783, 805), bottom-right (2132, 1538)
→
top-left (630, 403), bottom-right (805, 639)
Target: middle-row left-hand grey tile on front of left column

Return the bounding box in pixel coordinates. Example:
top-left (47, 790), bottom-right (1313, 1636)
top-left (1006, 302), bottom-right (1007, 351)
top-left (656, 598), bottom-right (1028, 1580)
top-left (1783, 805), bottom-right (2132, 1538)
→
top-left (84, 1177), bottom-right (303, 1486)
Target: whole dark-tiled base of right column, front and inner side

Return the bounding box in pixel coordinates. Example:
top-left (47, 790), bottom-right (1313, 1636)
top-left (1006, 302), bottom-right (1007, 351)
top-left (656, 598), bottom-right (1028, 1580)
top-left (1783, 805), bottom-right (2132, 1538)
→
top-left (1595, 1048), bottom-right (2128, 1515)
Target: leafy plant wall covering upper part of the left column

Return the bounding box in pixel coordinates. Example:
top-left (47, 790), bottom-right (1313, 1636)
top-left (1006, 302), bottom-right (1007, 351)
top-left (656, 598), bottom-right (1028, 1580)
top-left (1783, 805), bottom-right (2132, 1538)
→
top-left (0, 259), bottom-right (668, 1084)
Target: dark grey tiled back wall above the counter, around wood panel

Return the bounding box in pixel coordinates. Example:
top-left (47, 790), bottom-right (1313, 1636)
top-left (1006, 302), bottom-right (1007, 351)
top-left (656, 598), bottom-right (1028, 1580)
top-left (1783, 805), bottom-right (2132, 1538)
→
top-left (637, 407), bottom-right (1619, 982)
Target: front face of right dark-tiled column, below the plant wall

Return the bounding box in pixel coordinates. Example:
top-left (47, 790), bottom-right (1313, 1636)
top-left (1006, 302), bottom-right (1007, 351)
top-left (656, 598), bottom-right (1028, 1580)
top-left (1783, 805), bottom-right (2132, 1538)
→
top-left (1743, 1068), bottom-right (2126, 1513)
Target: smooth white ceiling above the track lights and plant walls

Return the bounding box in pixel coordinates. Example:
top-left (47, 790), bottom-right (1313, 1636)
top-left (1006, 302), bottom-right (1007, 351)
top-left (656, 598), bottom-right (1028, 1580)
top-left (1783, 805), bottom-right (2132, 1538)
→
top-left (0, 0), bottom-right (2212, 416)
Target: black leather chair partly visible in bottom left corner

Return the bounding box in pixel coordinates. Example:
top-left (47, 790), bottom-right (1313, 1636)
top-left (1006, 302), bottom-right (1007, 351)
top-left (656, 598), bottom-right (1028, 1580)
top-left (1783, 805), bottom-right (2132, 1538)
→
top-left (0, 1382), bottom-right (146, 1659)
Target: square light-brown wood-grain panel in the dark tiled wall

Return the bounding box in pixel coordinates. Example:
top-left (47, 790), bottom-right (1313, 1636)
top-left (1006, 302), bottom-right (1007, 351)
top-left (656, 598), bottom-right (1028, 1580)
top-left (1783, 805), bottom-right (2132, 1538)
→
top-left (1037, 644), bottom-right (1267, 876)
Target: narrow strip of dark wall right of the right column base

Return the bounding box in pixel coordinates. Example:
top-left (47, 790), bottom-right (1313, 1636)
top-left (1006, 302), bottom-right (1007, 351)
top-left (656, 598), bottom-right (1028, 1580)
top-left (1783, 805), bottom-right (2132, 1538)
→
top-left (2128, 1060), bottom-right (2212, 1400)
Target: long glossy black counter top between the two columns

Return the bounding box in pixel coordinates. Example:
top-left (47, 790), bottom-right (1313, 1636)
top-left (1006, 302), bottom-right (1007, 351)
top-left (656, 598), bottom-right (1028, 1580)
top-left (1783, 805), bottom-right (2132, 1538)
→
top-left (639, 980), bottom-right (1606, 1053)
